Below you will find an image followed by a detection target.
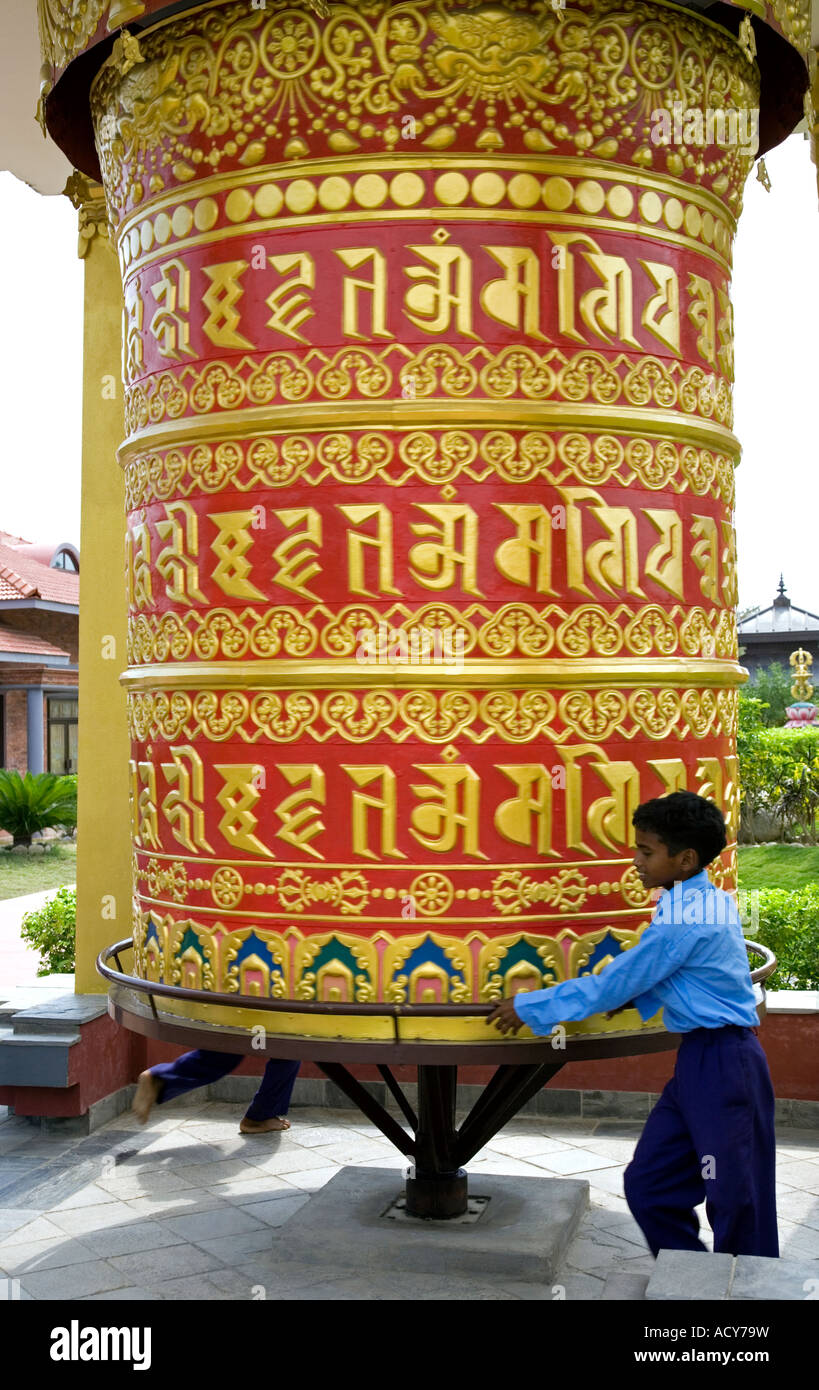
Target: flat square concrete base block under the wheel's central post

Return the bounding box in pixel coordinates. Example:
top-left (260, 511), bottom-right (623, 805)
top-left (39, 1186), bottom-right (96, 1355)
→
top-left (277, 1168), bottom-right (588, 1283)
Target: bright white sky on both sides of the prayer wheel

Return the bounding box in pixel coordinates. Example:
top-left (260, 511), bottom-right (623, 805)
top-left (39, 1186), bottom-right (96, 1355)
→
top-left (0, 135), bottom-right (819, 612)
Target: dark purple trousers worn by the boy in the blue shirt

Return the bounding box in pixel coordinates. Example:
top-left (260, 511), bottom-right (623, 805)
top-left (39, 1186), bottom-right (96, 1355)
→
top-left (623, 1024), bottom-right (779, 1255)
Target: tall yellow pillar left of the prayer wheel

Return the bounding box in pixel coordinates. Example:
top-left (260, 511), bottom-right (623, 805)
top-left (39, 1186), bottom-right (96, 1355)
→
top-left (67, 175), bottom-right (131, 994)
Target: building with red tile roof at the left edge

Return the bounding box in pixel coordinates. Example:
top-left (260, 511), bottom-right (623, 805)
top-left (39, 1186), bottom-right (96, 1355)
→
top-left (0, 531), bottom-right (79, 773)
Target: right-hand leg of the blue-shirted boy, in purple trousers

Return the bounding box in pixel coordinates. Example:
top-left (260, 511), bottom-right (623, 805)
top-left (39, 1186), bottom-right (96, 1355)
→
top-left (680, 1029), bottom-right (779, 1257)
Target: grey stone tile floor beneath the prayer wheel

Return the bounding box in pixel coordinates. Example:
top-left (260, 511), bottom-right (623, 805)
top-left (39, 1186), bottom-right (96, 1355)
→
top-left (0, 1097), bottom-right (819, 1301)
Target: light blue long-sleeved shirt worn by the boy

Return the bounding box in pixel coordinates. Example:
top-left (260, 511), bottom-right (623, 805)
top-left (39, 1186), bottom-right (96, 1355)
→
top-left (514, 870), bottom-right (759, 1034)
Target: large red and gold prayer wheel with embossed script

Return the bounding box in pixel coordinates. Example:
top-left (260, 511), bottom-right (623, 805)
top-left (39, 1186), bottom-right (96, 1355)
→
top-left (44, 0), bottom-right (806, 1044)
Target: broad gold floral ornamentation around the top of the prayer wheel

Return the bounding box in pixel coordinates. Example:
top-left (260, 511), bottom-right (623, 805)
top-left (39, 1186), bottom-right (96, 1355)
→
top-left (92, 0), bottom-right (758, 225)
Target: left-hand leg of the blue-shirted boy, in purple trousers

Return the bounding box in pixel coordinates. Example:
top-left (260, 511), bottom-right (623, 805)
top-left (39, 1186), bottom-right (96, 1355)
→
top-left (623, 1070), bottom-right (705, 1257)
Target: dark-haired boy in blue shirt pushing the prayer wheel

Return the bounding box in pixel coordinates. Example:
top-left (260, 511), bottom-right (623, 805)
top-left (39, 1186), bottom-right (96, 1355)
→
top-left (487, 791), bottom-right (779, 1255)
